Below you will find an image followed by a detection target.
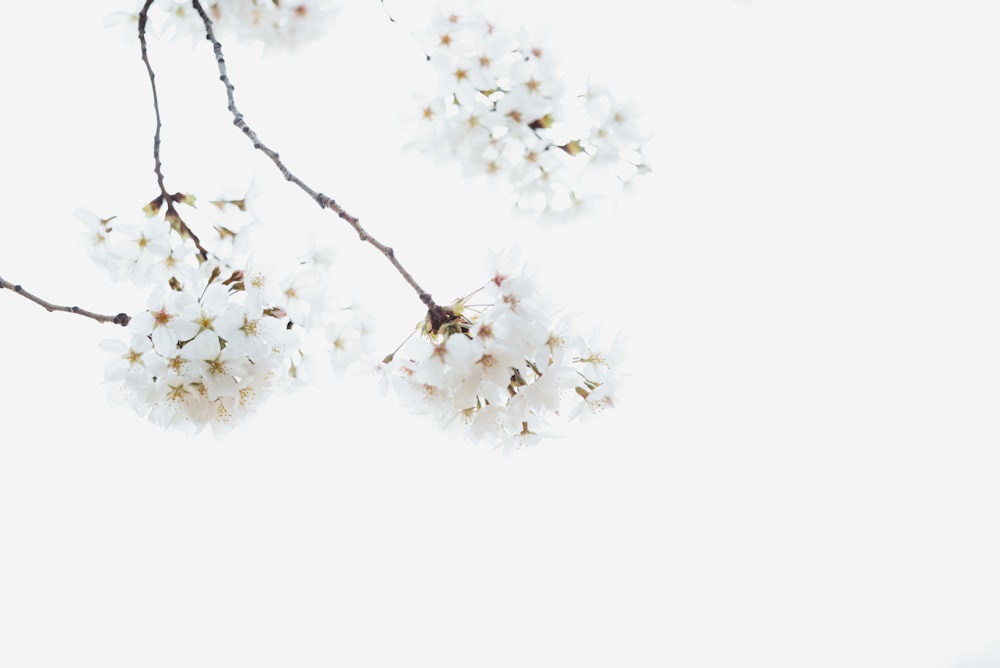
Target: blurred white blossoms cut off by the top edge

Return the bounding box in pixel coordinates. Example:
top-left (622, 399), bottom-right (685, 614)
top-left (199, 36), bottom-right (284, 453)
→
top-left (109, 0), bottom-right (340, 49)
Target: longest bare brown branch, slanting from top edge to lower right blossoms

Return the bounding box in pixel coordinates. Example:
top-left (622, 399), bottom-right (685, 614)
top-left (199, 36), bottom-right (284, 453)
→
top-left (192, 0), bottom-right (438, 315)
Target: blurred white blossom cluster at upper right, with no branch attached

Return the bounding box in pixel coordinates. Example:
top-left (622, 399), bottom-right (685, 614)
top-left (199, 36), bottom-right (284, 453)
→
top-left (410, 5), bottom-right (649, 217)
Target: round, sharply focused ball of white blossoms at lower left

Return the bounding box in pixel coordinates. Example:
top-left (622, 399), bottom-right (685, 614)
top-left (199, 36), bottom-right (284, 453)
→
top-left (102, 263), bottom-right (297, 430)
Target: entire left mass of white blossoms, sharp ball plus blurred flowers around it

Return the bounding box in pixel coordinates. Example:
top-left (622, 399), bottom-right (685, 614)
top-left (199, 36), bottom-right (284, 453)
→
top-left (77, 195), bottom-right (371, 431)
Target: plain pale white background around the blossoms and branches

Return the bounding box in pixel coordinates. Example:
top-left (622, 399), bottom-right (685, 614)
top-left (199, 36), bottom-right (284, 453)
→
top-left (0, 0), bottom-right (1000, 668)
